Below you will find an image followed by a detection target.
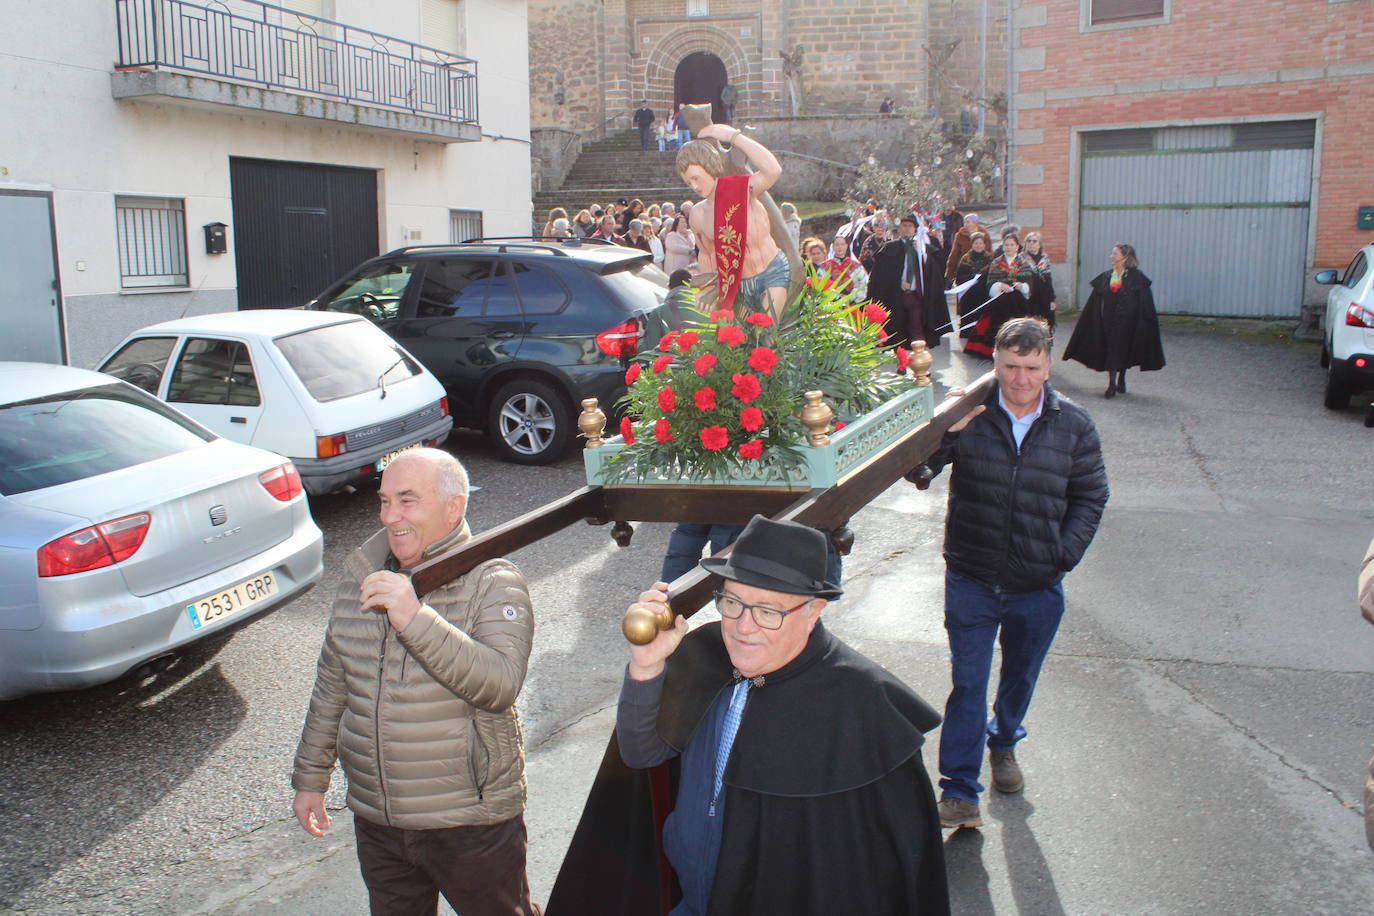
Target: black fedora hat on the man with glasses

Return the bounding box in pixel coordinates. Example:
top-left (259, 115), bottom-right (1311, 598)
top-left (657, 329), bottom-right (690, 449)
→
top-left (701, 515), bottom-right (844, 599)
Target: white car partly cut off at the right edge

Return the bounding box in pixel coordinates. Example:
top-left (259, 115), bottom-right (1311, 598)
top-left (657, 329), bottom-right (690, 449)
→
top-left (1315, 244), bottom-right (1374, 411)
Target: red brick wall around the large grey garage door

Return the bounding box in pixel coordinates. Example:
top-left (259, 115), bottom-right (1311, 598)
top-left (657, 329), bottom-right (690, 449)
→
top-left (1013, 0), bottom-right (1374, 297)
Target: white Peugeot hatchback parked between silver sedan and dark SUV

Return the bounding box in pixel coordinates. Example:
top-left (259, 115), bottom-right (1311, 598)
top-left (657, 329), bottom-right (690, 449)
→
top-left (99, 309), bottom-right (453, 494)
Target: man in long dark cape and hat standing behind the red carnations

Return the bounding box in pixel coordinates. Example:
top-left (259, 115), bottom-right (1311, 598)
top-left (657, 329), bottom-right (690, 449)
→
top-left (868, 213), bottom-right (949, 347)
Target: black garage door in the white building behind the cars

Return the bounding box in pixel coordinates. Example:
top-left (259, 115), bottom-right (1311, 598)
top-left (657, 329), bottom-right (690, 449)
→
top-left (229, 158), bottom-right (378, 309)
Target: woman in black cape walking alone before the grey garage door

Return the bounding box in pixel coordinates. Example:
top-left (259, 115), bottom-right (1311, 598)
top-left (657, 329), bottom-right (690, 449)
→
top-left (1063, 243), bottom-right (1164, 398)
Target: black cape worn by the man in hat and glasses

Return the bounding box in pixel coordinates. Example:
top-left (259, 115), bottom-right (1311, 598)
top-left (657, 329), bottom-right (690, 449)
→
top-left (544, 623), bottom-right (949, 916)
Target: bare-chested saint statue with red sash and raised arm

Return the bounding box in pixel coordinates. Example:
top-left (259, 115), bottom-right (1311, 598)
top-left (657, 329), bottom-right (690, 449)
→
top-left (677, 104), bottom-right (805, 321)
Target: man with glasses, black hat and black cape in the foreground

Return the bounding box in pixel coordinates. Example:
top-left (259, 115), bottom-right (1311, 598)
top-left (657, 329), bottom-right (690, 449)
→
top-left (545, 515), bottom-right (949, 916)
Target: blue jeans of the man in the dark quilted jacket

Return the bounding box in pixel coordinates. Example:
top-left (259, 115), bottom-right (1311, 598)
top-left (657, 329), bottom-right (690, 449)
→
top-left (940, 570), bottom-right (1063, 805)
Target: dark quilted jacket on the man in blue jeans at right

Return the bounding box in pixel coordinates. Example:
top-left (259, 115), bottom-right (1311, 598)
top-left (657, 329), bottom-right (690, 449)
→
top-left (927, 385), bottom-right (1107, 593)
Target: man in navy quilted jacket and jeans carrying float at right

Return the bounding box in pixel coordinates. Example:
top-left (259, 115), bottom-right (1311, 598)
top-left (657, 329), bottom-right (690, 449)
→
top-left (929, 319), bottom-right (1107, 827)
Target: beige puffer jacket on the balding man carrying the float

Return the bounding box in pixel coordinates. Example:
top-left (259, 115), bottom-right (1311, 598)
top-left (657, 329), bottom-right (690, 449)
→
top-left (291, 522), bottom-right (534, 829)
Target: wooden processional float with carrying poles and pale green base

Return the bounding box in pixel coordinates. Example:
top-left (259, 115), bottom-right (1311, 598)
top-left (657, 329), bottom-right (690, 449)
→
top-left (411, 354), bottom-right (993, 634)
